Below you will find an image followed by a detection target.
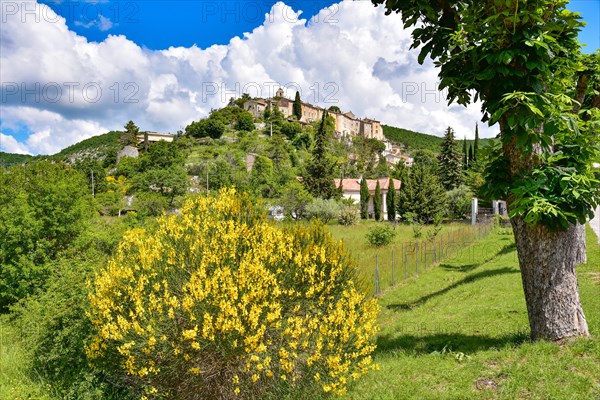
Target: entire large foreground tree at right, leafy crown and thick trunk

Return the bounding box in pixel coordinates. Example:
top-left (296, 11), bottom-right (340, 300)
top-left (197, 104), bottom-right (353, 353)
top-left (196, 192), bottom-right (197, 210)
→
top-left (372, 0), bottom-right (600, 340)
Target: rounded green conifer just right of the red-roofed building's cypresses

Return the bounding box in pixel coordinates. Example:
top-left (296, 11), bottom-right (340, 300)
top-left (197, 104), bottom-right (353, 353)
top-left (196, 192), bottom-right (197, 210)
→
top-left (398, 163), bottom-right (446, 224)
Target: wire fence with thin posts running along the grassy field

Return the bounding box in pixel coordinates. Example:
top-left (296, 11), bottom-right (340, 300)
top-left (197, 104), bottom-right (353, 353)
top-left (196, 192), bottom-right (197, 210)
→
top-left (357, 220), bottom-right (494, 296)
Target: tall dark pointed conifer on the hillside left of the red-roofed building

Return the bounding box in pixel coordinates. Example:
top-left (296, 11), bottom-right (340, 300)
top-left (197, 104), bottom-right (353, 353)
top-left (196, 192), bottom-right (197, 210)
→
top-left (304, 112), bottom-right (337, 199)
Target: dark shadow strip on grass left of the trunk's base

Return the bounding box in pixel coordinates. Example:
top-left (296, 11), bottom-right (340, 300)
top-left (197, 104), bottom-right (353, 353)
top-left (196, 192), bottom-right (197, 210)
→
top-left (376, 327), bottom-right (529, 355)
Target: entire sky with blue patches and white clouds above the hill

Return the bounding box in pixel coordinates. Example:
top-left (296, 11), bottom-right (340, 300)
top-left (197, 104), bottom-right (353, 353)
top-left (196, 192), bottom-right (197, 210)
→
top-left (0, 0), bottom-right (600, 154)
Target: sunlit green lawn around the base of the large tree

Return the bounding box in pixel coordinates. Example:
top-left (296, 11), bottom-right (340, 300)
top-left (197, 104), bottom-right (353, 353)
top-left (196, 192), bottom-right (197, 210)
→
top-left (344, 228), bottom-right (600, 399)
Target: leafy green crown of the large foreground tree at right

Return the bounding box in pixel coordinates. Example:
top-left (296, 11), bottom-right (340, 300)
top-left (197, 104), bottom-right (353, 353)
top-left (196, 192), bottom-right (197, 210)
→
top-left (373, 0), bottom-right (600, 229)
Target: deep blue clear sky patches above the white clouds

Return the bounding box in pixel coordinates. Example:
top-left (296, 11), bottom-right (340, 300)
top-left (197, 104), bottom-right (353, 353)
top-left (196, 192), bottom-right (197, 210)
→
top-left (37, 0), bottom-right (600, 52)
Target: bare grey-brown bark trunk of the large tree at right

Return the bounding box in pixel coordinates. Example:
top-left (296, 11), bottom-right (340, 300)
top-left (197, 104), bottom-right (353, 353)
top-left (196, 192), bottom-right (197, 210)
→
top-left (511, 217), bottom-right (589, 340)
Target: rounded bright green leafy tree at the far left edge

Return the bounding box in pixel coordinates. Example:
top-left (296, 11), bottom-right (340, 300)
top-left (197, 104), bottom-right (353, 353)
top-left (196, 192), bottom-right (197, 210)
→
top-left (0, 161), bottom-right (92, 311)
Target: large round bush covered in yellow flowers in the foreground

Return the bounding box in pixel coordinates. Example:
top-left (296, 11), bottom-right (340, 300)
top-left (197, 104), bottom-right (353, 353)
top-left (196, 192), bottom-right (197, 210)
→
top-left (87, 189), bottom-right (378, 399)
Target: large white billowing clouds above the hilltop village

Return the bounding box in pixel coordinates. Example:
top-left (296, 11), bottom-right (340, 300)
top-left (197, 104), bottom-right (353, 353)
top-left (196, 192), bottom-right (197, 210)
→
top-left (0, 0), bottom-right (496, 153)
